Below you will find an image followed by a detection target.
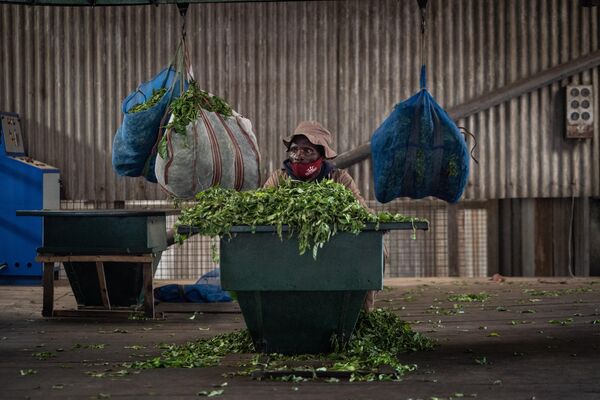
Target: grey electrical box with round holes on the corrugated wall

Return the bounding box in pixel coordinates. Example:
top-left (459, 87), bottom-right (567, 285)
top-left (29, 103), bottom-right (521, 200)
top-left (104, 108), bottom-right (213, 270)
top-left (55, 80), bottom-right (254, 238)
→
top-left (566, 85), bottom-right (594, 139)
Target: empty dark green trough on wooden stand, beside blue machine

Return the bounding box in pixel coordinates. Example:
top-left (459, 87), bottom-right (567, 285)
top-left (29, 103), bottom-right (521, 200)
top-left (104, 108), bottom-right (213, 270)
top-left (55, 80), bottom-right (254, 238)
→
top-left (17, 209), bottom-right (177, 318)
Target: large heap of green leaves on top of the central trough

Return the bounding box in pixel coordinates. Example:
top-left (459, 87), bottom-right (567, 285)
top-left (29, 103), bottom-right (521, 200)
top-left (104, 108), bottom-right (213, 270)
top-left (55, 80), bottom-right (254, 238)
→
top-left (176, 179), bottom-right (422, 258)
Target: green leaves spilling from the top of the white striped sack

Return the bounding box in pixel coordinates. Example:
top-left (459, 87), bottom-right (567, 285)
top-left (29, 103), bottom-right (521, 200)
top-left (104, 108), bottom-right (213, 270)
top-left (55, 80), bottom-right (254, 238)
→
top-left (167, 80), bottom-right (233, 135)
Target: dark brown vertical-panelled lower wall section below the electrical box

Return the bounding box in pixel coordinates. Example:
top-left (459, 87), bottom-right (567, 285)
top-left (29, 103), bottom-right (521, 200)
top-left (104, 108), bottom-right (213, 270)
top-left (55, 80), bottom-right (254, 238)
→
top-left (488, 197), bottom-right (595, 276)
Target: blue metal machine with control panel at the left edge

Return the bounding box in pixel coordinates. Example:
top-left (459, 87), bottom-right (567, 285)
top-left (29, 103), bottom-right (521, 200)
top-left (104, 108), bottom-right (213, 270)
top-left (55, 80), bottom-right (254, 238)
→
top-left (0, 112), bottom-right (60, 285)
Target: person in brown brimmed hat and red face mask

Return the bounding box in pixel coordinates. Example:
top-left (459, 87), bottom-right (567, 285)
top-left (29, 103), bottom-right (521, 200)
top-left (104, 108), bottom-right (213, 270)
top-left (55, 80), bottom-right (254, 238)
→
top-left (263, 121), bottom-right (375, 311)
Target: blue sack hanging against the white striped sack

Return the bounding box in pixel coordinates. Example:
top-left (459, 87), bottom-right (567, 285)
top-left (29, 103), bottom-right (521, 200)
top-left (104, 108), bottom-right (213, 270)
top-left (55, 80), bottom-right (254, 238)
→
top-left (112, 65), bottom-right (185, 183)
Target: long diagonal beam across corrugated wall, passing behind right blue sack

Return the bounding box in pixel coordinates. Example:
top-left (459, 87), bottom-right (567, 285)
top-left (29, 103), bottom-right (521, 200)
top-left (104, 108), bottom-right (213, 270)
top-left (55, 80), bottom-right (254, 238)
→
top-left (333, 50), bottom-right (600, 168)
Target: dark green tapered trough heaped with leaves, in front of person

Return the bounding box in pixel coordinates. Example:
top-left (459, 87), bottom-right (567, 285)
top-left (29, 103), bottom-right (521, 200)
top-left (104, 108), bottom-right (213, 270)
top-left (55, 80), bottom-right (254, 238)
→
top-left (179, 222), bottom-right (428, 354)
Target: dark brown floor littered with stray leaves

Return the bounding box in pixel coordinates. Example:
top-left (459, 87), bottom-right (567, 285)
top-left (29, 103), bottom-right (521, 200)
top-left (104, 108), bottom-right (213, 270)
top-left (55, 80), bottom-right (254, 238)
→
top-left (0, 278), bottom-right (600, 400)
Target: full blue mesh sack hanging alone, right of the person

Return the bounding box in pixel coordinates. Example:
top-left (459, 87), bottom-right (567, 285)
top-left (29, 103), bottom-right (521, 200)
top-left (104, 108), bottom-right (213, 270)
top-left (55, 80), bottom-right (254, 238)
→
top-left (371, 65), bottom-right (469, 203)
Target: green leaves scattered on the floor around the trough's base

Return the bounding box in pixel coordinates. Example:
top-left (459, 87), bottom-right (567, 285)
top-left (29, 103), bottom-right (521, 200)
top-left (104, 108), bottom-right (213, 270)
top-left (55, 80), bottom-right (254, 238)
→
top-left (125, 310), bottom-right (435, 381)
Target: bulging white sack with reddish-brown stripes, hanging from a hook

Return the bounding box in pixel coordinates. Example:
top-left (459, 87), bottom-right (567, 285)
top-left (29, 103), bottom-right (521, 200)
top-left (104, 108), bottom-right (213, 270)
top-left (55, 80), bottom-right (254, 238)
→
top-left (155, 107), bottom-right (261, 199)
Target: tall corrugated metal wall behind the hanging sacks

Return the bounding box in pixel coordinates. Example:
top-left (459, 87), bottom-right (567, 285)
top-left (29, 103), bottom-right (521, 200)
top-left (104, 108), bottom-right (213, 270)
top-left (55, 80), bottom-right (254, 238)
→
top-left (0, 0), bottom-right (600, 201)
